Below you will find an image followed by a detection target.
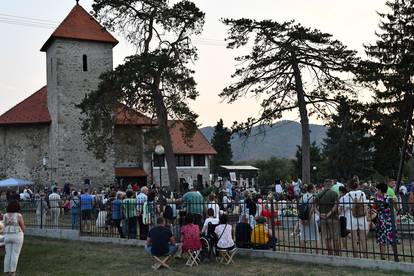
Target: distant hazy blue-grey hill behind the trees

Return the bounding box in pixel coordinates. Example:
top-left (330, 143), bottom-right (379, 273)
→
top-left (200, 121), bottom-right (326, 162)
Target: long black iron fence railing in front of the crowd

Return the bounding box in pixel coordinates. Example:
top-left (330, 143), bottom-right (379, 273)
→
top-left (4, 199), bottom-right (414, 262)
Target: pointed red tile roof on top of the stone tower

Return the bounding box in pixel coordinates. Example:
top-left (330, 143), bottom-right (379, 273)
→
top-left (40, 4), bottom-right (118, 52)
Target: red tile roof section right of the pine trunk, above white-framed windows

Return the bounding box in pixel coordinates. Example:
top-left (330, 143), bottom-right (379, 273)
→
top-left (169, 121), bottom-right (217, 155)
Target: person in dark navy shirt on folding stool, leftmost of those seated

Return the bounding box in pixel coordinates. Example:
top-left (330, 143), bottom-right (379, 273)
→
top-left (144, 217), bottom-right (178, 256)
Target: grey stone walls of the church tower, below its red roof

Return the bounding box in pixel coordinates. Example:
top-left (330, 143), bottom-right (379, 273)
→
top-left (46, 39), bottom-right (115, 186)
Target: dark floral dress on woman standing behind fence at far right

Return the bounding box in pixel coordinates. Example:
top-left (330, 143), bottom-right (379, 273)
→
top-left (375, 195), bottom-right (397, 245)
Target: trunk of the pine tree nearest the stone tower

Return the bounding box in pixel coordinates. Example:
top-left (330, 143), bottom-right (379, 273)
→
top-left (154, 82), bottom-right (180, 193)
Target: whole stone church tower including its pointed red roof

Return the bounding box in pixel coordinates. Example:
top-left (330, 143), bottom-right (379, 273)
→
top-left (41, 4), bottom-right (118, 186)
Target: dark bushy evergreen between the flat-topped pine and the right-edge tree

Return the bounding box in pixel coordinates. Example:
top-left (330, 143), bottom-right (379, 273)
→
top-left (323, 98), bottom-right (373, 179)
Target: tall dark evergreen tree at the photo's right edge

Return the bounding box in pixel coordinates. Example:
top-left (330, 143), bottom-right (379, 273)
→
top-left (360, 0), bottom-right (414, 188)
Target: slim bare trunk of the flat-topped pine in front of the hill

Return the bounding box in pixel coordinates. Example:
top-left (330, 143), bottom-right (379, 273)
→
top-left (292, 53), bottom-right (310, 184)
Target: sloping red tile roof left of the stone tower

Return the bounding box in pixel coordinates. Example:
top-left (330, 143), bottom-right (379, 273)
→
top-left (0, 86), bottom-right (51, 125)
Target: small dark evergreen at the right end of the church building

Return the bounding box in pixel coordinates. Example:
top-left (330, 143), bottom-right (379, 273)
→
top-left (211, 119), bottom-right (233, 172)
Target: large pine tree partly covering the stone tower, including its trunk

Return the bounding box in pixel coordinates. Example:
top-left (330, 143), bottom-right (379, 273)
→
top-left (80, 0), bottom-right (204, 191)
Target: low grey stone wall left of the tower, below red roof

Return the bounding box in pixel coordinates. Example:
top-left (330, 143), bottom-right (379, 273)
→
top-left (0, 125), bottom-right (49, 185)
